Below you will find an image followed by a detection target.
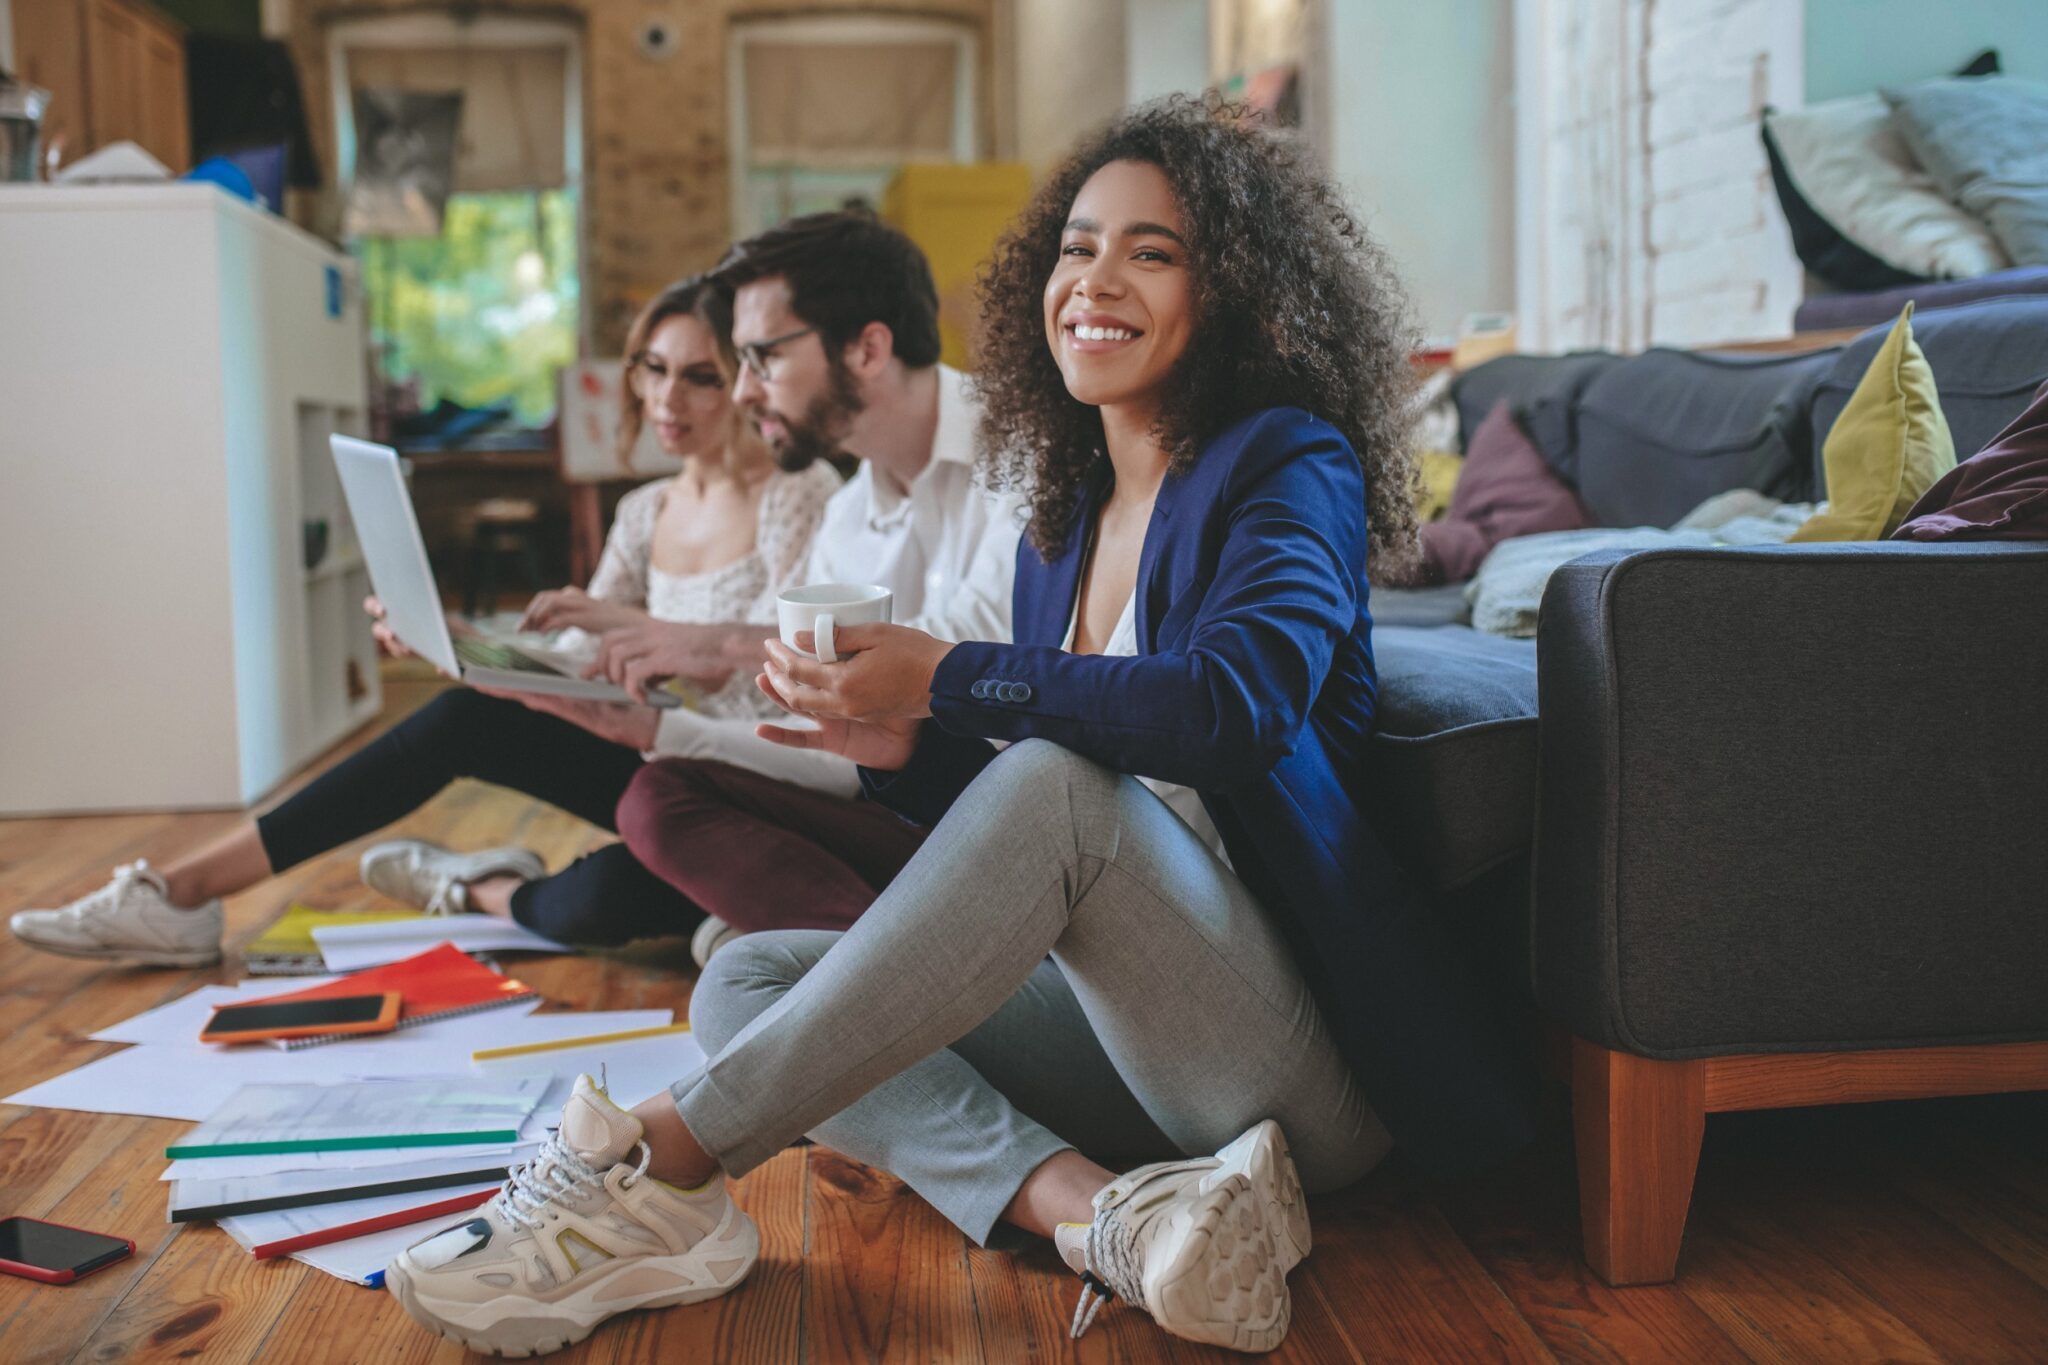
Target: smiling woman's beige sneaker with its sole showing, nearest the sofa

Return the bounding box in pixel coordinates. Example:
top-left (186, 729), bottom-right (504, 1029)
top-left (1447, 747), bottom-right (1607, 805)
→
top-left (1053, 1119), bottom-right (1309, 1351)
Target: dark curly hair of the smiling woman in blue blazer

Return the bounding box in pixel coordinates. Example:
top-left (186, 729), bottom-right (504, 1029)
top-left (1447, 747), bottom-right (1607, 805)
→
top-left (975, 96), bottom-right (1415, 569)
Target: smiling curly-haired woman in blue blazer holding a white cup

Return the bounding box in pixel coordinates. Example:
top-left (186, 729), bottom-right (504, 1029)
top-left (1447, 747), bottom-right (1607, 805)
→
top-left (380, 102), bottom-right (1530, 1351)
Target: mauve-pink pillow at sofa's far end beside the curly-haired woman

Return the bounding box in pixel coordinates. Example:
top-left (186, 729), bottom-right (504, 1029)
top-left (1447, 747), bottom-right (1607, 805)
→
top-left (1421, 399), bottom-right (1595, 583)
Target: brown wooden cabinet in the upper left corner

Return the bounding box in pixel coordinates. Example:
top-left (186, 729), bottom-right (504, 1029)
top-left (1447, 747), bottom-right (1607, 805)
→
top-left (12, 0), bottom-right (193, 174)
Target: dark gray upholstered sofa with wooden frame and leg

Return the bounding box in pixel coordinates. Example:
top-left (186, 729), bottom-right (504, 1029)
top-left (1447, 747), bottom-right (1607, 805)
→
top-left (1374, 299), bottom-right (2048, 1283)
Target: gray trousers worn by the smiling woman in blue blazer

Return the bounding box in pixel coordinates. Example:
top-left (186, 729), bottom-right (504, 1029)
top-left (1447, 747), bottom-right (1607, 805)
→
top-left (670, 739), bottom-right (1391, 1242)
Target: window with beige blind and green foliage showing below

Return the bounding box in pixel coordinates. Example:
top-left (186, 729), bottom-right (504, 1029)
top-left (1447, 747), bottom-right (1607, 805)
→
top-left (330, 14), bottom-right (586, 446)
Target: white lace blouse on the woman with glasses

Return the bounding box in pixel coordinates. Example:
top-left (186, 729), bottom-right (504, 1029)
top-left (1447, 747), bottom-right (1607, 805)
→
top-left (590, 460), bottom-right (840, 718)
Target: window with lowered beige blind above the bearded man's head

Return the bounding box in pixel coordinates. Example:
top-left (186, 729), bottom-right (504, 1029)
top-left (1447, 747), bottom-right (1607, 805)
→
top-left (727, 14), bottom-right (977, 237)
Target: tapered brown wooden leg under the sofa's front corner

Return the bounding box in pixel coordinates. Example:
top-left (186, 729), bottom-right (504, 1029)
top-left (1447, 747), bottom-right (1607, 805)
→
top-left (1571, 1038), bottom-right (1706, 1285)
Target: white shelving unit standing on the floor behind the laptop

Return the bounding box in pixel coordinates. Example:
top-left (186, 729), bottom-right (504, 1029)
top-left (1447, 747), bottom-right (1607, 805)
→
top-left (0, 184), bottom-right (381, 814)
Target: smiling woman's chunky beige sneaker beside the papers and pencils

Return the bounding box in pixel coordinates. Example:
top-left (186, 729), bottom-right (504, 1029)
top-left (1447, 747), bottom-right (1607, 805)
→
top-left (385, 1076), bottom-right (760, 1355)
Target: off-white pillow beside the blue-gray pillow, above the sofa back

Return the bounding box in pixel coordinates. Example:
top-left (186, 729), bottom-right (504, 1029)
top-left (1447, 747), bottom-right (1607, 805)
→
top-left (1763, 94), bottom-right (2013, 280)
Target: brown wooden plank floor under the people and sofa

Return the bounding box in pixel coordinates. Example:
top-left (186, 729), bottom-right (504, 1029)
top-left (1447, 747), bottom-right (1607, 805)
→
top-left (0, 681), bottom-right (2048, 1365)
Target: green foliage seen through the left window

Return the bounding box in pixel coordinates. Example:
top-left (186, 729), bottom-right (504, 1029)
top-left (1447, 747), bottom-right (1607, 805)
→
top-left (354, 190), bottom-right (580, 426)
